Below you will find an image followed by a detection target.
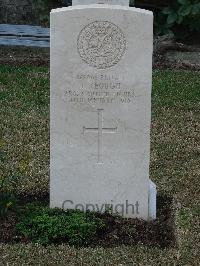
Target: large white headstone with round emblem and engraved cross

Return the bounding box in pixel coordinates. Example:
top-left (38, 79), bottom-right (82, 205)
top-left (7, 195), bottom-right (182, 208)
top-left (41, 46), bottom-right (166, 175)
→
top-left (50, 5), bottom-right (155, 219)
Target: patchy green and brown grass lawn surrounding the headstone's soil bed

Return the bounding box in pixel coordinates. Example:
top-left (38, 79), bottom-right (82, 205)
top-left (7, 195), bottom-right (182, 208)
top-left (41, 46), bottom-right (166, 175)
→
top-left (0, 66), bottom-right (200, 266)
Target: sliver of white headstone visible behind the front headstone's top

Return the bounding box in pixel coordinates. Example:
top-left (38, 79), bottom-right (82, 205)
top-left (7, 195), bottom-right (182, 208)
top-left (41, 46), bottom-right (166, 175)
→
top-left (72, 0), bottom-right (129, 6)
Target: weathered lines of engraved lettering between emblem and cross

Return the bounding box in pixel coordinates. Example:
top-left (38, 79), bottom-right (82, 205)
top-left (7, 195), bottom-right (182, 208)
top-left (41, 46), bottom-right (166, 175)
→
top-left (63, 73), bottom-right (138, 104)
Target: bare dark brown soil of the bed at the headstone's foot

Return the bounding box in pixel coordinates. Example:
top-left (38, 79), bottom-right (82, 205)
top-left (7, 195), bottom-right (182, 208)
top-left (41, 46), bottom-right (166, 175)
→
top-left (0, 194), bottom-right (176, 248)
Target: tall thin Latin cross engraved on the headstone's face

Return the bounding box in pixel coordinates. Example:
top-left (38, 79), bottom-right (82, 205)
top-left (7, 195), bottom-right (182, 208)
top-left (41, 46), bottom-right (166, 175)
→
top-left (83, 109), bottom-right (117, 164)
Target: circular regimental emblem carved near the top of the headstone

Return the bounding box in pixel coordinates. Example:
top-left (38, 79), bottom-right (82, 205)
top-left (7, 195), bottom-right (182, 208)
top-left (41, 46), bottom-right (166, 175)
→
top-left (77, 21), bottom-right (126, 69)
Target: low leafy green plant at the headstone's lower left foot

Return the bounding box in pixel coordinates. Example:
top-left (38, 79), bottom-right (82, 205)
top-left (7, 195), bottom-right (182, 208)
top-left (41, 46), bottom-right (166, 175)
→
top-left (16, 205), bottom-right (105, 246)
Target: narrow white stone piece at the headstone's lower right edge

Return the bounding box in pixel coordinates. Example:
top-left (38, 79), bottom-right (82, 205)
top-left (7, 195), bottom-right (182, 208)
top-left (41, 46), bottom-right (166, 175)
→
top-left (149, 181), bottom-right (157, 220)
